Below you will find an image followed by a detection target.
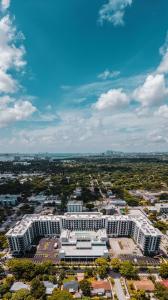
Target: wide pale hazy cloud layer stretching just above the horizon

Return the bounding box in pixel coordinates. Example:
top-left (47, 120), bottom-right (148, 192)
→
top-left (5, 106), bottom-right (167, 152)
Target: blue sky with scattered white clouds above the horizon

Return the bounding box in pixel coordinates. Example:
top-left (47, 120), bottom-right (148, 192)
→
top-left (0, 0), bottom-right (168, 153)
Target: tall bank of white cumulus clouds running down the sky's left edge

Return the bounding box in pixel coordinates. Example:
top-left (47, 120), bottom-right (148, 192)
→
top-left (0, 0), bottom-right (36, 127)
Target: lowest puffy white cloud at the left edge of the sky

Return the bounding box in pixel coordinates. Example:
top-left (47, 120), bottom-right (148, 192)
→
top-left (0, 96), bottom-right (36, 127)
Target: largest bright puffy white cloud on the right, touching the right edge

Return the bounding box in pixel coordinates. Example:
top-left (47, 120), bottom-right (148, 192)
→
top-left (133, 74), bottom-right (168, 106)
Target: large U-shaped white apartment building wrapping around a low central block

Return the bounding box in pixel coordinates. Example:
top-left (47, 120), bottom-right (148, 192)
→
top-left (6, 212), bottom-right (161, 255)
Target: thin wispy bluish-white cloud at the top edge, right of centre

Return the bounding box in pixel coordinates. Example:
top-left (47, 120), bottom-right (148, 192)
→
top-left (99, 0), bottom-right (133, 26)
